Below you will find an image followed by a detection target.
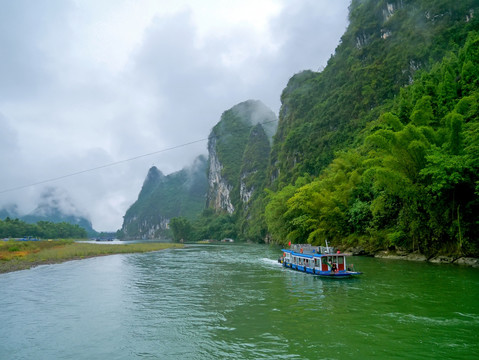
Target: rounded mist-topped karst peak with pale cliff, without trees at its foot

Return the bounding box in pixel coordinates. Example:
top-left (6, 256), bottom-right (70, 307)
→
top-left (207, 100), bottom-right (277, 214)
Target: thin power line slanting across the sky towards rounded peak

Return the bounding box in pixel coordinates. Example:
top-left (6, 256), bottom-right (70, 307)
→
top-left (0, 120), bottom-right (278, 194)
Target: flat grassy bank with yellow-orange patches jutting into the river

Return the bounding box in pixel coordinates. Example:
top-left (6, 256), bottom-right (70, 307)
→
top-left (0, 240), bottom-right (183, 274)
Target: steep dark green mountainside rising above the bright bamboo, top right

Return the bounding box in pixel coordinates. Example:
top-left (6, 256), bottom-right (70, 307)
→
top-left (271, 0), bottom-right (479, 187)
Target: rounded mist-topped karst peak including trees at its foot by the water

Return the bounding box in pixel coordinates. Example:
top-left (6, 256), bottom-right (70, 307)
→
top-left (186, 100), bottom-right (277, 241)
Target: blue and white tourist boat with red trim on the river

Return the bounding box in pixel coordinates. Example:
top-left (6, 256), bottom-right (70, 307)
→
top-left (278, 244), bottom-right (362, 279)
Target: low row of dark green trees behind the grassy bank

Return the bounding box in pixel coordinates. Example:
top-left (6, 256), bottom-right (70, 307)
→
top-left (0, 217), bottom-right (87, 239)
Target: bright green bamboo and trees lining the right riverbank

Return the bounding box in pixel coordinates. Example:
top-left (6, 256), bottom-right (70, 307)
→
top-left (266, 32), bottom-right (479, 255)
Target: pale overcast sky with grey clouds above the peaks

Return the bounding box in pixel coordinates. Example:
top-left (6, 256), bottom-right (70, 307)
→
top-left (0, 0), bottom-right (349, 231)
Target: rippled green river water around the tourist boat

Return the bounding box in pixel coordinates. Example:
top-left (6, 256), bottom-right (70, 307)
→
top-left (0, 244), bottom-right (479, 360)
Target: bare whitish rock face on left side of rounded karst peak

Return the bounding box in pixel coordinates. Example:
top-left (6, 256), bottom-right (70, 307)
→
top-left (208, 136), bottom-right (235, 214)
